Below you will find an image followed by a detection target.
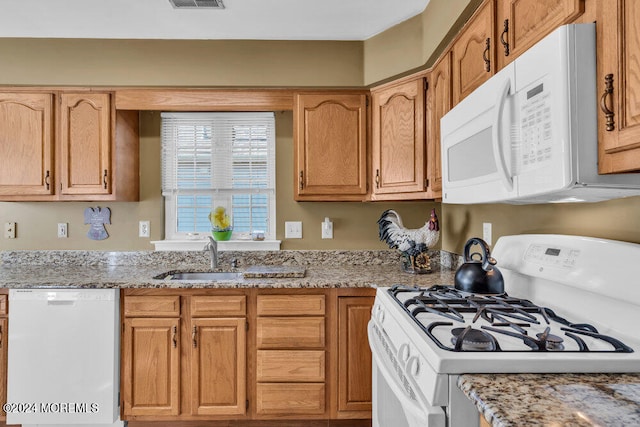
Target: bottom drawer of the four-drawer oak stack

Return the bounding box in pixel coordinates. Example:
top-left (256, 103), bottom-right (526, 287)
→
top-left (256, 383), bottom-right (325, 415)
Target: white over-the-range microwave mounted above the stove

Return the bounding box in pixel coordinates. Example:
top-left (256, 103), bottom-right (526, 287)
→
top-left (441, 24), bottom-right (640, 203)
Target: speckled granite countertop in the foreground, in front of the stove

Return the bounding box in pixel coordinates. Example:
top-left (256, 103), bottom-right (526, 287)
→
top-left (458, 374), bottom-right (640, 427)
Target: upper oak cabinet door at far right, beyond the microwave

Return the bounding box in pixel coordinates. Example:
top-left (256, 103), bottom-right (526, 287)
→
top-left (597, 0), bottom-right (640, 173)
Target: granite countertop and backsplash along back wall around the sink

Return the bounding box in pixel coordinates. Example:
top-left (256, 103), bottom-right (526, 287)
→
top-left (0, 251), bottom-right (454, 288)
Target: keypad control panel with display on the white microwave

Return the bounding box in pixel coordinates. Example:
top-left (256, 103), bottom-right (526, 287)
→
top-left (517, 82), bottom-right (553, 171)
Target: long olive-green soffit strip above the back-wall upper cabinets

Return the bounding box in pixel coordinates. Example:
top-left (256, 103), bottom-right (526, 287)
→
top-left (0, 38), bottom-right (363, 87)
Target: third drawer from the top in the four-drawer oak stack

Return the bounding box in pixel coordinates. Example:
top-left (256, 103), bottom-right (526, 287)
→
top-left (256, 350), bottom-right (325, 382)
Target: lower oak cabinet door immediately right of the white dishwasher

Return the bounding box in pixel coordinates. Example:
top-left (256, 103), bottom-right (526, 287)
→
top-left (122, 318), bottom-right (180, 416)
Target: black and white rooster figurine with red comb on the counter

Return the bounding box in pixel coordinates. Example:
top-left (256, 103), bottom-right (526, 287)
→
top-left (378, 209), bottom-right (440, 273)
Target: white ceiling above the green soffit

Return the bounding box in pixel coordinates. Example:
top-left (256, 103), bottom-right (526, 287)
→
top-left (0, 0), bottom-right (429, 40)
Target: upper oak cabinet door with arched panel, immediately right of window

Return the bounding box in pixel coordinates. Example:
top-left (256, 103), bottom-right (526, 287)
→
top-left (293, 93), bottom-right (367, 200)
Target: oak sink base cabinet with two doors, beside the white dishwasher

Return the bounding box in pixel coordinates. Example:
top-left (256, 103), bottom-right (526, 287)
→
top-left (121, 289), bottom-right (247, 421)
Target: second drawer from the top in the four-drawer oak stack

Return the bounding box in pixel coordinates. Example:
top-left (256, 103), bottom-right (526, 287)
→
top-left (256, 317), bottom-right (325, 348)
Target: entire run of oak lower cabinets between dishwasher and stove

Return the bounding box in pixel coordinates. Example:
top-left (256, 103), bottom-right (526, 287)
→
top-left (120, 289), bottom-right (375, 422)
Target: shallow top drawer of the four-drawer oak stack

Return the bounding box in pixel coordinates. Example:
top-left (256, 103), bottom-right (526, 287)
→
top-left (258, 295), bottom-right (325, 316)
